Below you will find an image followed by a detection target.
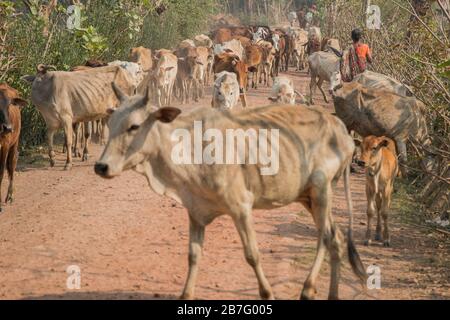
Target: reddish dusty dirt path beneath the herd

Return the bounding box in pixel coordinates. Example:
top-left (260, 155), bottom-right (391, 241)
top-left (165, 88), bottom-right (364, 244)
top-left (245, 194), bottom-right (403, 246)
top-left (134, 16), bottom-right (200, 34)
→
top-left (0, 73), bottom-right (450, 299)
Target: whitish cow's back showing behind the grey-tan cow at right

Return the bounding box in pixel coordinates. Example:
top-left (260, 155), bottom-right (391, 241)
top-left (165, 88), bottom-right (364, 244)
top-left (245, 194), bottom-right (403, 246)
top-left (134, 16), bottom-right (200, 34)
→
top-left (353, 70), bottom-right (414, 97)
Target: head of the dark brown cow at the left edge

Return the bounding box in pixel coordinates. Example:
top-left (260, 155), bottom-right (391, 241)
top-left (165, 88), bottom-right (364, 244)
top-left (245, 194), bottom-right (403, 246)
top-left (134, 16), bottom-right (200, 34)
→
top-left (0, 83), bottom-right (27, 135)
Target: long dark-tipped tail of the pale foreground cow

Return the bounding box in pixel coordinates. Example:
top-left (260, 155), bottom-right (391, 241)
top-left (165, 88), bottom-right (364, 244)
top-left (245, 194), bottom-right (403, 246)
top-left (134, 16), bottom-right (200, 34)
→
top-left (344, 165), bottom-right (367, 282)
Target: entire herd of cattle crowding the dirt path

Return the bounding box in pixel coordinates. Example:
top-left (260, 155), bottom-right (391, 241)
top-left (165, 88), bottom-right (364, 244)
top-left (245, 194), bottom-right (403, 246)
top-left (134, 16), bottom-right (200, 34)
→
top-left (0, 21), bottom-right (427, 299)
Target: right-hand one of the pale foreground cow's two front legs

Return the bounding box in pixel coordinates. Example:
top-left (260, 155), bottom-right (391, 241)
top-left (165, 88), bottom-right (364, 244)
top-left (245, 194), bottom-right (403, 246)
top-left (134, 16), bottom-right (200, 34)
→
top-left (233, 210), bottom-right (274, 300)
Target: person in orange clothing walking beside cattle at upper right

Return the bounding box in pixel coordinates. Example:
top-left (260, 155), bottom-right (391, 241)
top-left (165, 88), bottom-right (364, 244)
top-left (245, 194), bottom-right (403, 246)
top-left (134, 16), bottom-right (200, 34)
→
top-left (344, 29), bottom-right (373, 81)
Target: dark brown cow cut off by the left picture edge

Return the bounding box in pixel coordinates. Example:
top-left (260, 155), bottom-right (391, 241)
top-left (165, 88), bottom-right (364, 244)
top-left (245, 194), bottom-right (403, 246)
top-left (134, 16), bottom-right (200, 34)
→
top-left (0, 83), bottom-right (27, 212)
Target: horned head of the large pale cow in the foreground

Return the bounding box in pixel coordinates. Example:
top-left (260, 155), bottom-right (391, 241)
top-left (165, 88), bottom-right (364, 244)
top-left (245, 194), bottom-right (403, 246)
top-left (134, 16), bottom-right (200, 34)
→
top-left (95, 84), bottom-right (181, 179)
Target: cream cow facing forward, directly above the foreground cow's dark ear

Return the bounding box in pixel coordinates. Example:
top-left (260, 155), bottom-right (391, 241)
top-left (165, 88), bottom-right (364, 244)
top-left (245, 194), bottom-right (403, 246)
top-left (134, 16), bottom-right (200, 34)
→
top-left (154, 50), bottom-right (178, 107)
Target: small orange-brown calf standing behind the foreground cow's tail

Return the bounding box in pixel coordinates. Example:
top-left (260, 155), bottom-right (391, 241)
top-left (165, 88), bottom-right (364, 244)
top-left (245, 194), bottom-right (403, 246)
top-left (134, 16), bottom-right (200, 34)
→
top-left (357, 136), bottom-right (398, 247)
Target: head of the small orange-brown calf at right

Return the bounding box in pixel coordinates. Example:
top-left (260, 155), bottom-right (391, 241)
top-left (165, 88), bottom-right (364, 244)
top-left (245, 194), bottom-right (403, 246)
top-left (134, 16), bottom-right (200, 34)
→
top-left (355, 136), bottom-right (393, 177)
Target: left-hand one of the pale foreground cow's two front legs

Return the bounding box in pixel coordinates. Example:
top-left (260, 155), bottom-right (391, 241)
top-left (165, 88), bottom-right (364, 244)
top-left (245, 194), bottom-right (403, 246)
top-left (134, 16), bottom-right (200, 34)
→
top-left (181, 217), bottom-right (205, 300)
